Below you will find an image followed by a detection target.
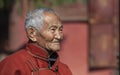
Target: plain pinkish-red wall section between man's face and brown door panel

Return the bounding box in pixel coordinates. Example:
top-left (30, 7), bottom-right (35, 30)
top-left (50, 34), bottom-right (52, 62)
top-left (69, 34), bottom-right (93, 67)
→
top-left (59, 23), bottom-right (111, 75)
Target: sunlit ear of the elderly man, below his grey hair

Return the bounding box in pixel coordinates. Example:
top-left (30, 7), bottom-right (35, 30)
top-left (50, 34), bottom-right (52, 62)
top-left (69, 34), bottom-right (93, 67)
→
top-left (27, 26), bottom-right (37, 42)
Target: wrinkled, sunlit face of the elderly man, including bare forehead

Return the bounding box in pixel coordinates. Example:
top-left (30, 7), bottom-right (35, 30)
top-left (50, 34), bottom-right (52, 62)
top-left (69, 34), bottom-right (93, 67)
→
top-left (36, 13), bottom-right (63, 51)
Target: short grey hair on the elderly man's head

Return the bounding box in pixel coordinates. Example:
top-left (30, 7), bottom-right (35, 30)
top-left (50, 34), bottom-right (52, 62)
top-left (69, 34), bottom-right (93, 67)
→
top-left (25, 8), bottom-right (57, 30)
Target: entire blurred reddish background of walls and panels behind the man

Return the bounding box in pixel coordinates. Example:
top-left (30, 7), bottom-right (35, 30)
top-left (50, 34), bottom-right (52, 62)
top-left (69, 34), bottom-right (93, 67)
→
top-left (0, 0), bottom-right (119, 75)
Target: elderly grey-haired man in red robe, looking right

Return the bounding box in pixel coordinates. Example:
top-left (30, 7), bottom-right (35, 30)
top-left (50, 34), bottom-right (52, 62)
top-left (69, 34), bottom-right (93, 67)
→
top-left (0, 8), bottom-right (72, 75)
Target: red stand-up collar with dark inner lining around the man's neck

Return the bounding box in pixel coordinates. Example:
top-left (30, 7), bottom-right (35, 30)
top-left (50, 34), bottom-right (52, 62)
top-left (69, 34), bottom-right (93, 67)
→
top-left (26, 43), bottom-right (58, 61)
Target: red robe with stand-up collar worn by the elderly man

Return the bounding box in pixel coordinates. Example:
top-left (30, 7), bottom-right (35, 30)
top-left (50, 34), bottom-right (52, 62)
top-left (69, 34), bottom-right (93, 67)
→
top-left (0, 43), bottom-right (72, 75)
